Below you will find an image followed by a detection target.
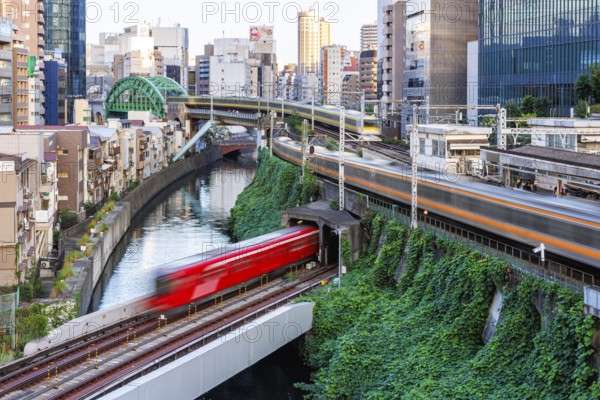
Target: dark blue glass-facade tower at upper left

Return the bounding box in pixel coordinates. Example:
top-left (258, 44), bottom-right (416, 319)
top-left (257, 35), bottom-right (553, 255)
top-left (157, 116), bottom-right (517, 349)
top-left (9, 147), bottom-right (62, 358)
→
top-left (44, 0), bottom-right (86, 122)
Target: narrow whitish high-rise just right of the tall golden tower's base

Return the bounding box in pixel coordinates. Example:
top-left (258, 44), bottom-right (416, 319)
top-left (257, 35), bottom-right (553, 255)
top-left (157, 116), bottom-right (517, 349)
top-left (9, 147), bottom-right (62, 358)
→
top-left (319, 44), bottom-right (346, 105)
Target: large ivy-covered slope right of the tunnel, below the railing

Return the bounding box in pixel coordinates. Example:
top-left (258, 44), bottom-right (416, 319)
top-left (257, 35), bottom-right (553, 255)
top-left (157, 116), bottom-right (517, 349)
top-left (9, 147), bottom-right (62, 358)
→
top-left (299, 218), bottom-right (600, 399)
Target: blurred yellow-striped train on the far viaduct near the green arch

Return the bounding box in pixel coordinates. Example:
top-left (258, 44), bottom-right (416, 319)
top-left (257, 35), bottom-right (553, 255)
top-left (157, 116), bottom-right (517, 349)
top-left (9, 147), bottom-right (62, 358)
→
top-left (169, 96), bottom-right (380, 139)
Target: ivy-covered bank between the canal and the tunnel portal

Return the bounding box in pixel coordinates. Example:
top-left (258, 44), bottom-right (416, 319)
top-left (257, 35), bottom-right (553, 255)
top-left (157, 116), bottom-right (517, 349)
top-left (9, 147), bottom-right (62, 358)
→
top-left (228, 149), bottom-right (319, 240)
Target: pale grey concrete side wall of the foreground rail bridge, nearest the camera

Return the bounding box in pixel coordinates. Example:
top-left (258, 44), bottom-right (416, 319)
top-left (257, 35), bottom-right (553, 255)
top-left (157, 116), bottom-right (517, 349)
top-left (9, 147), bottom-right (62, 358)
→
top-left (103, 303), bottom-right (314, 400)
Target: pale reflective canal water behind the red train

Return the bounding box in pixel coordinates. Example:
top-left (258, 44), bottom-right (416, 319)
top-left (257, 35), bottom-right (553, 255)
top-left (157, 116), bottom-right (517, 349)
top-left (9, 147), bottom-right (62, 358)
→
top-left (99, 155), bottom-right (256, 310)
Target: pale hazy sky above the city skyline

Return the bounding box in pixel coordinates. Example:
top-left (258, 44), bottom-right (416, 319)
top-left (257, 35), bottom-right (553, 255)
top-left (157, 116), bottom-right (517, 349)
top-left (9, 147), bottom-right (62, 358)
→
top-left (87, 0), bottom-right (377, 65)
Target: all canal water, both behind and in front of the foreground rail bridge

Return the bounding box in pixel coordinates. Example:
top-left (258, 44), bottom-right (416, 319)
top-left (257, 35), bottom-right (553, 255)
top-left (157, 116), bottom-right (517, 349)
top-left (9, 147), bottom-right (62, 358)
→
top-left (94, 155), bottom-right (308, 400)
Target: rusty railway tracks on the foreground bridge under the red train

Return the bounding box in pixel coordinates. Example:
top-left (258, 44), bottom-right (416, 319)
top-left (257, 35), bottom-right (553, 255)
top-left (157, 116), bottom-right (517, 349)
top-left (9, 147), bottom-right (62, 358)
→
top-left (0, 268), bottom-right (333, 400)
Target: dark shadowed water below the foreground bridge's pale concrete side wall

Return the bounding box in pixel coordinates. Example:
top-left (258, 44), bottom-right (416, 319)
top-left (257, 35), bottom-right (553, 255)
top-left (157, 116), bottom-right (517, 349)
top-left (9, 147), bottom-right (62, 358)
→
top-left (203, 339), bottom-right (310, 400)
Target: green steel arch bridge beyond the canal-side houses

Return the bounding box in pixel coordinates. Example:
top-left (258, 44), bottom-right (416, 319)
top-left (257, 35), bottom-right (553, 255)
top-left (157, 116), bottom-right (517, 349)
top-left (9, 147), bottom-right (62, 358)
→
top-left (104, 76), bottom-right (188, 118)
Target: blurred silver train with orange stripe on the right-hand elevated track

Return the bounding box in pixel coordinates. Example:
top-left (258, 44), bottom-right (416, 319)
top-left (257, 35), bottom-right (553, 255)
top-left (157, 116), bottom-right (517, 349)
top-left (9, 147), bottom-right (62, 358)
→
top-left (273, 137), bottom-right (600, 268)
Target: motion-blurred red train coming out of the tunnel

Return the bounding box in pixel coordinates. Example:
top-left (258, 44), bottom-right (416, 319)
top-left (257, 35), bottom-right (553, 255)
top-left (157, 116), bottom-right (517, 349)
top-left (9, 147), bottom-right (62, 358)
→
top-left (148, 225), bottom-right (319, 311)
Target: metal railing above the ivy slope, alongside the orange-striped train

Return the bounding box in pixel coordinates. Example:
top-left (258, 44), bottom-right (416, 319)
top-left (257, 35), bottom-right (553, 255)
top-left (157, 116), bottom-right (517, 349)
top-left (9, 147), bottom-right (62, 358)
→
top-left (346, 189), bottom-right (600, 291)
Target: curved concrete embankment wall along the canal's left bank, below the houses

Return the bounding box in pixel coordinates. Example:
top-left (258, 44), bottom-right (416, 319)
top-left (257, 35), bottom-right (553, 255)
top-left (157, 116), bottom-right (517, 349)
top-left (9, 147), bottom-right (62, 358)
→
top-left (72, 148), bottom-right (221, 315)
